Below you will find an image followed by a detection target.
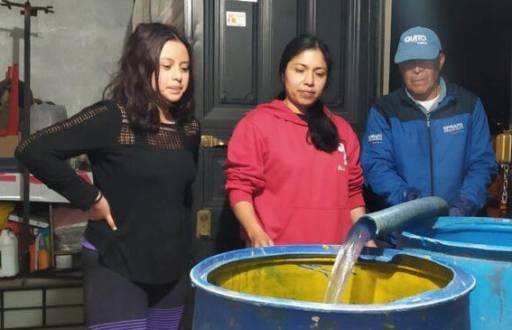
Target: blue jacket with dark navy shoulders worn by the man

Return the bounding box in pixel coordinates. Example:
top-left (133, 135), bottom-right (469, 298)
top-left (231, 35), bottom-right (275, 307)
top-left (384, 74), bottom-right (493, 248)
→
top-left (361, 81), bottom-right (497, 215)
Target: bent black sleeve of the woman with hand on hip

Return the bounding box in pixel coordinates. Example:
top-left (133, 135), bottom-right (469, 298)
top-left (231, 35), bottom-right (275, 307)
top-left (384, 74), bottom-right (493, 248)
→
top-left (15, 103), bottom-right (121, 210)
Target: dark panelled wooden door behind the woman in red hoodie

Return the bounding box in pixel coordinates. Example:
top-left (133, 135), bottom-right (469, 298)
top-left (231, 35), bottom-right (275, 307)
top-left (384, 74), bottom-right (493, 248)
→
top-left (185, 0), bottom-right (383, 259)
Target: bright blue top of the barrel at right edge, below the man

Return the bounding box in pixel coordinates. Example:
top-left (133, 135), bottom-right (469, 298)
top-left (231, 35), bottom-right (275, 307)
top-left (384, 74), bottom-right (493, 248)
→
top-left (400, 217), bottom-right (512, 261)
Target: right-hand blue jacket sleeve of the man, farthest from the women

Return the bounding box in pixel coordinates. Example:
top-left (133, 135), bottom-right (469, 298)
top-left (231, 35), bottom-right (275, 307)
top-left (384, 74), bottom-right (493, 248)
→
top-left (459, 99), bottom-right (498, 209)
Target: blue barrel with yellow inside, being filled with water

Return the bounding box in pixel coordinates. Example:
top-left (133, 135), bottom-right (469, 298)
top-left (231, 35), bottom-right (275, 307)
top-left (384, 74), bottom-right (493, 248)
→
top-left (191, 245), bottom-right (475, 330)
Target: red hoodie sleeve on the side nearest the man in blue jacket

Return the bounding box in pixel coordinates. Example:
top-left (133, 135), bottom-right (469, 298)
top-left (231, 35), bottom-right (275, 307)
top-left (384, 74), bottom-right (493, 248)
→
top-left (346, 124), bottom-right (365, 209)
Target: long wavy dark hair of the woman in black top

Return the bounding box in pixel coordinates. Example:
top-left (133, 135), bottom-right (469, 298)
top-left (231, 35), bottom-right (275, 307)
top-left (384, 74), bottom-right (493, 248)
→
top-left (103, 23), bottom-right (194, 132)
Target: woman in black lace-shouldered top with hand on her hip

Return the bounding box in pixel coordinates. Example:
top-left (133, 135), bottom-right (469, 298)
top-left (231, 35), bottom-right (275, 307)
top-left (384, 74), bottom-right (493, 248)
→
top-left (16, 23), bottom-right (201, 329)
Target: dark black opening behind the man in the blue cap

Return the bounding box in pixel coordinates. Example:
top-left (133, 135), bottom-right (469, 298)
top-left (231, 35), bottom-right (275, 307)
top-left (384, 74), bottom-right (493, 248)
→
top-left (390, 0), bottom-right (512, 135)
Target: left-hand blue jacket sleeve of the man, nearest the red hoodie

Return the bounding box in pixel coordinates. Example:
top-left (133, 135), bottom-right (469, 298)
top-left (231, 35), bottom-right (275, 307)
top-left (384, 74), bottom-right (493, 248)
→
top-left (361, 107), bottom-right (407, 205)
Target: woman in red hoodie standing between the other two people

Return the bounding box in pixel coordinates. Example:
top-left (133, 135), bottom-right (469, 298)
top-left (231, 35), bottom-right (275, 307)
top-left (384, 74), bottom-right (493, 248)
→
top-left (225, 35), bottom-right (365, 247)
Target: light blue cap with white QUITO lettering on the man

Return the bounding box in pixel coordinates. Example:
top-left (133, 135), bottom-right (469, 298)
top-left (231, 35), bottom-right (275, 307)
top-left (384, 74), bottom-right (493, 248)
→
top-left (395, 26), bottom-right (442, 64)
